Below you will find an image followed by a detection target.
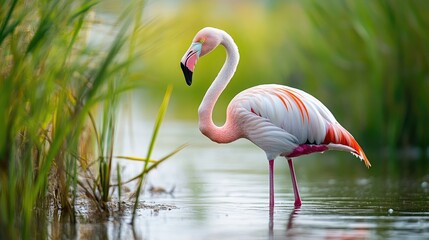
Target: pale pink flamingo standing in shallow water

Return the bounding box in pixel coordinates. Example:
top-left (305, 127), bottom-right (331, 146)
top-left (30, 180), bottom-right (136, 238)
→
top-left (180, 27), bottom-right (371, 209)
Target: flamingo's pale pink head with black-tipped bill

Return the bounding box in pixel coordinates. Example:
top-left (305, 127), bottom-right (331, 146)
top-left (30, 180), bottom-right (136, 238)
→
top-left (180, 27), bottom-right (222, 86)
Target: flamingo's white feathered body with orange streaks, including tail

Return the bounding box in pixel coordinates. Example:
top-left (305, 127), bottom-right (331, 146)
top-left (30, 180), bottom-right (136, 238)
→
top-left (227, 84), bottom-right (369, 166)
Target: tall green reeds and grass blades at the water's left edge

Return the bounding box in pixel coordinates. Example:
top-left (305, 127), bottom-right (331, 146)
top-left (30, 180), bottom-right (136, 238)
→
top-left (0, 0), bottom-right (181, 236)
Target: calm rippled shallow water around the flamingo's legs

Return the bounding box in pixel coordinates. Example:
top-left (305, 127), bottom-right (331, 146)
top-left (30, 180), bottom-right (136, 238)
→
top-left (51, 122), bottom-right (429, 239)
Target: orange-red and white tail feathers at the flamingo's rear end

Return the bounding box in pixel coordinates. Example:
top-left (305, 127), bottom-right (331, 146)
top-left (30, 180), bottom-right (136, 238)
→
top-left (323, 123), bottom-right (371, 168)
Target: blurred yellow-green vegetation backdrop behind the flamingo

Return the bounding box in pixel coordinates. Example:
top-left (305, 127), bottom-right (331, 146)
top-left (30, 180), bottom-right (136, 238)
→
top-left (125, 0), bottom-right (429, 159)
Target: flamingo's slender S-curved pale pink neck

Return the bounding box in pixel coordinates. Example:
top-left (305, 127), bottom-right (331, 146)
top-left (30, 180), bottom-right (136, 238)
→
top-left (198, 31), bottom-right (240, 143)
